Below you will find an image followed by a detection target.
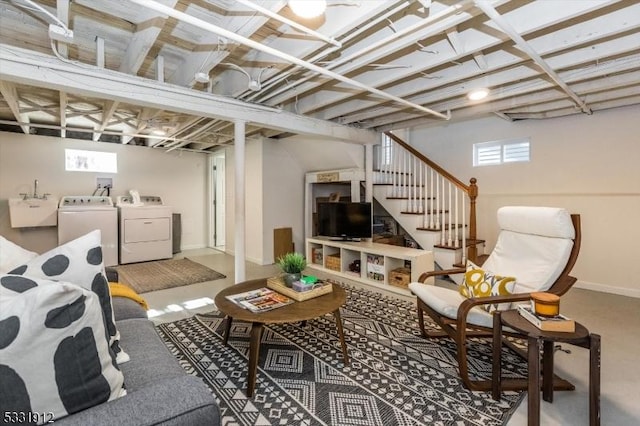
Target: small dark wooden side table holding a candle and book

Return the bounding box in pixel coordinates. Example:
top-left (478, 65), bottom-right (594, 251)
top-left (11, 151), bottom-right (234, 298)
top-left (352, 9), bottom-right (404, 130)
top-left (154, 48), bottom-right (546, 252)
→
top-left (491, 309), bottom-right (600, 426)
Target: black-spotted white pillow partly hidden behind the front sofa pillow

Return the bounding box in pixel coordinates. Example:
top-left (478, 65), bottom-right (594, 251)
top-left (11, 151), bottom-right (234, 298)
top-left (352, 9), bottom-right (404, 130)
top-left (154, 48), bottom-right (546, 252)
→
top-left (9, 230), bottom-right (129, 364)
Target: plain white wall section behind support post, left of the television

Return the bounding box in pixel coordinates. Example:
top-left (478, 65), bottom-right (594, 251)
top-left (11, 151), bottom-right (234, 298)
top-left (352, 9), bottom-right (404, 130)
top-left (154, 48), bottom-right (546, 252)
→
top-left (225, 137), bottom-right (364, 264)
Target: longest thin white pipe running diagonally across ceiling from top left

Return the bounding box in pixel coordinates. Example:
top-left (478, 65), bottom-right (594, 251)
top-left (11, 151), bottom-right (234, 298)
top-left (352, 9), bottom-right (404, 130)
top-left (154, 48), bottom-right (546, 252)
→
top-left (129, 0), bottom-right (451, 120)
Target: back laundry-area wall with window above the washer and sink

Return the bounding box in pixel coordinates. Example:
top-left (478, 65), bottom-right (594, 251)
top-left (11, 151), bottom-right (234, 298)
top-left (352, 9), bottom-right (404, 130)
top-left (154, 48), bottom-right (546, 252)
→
top-left (0, 132), bottom-right (207, 252)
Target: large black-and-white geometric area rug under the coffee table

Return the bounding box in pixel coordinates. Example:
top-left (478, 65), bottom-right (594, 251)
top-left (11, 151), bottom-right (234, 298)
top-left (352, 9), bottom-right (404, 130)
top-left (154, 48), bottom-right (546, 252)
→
top-left (158, 286), bottom-right (526, 426)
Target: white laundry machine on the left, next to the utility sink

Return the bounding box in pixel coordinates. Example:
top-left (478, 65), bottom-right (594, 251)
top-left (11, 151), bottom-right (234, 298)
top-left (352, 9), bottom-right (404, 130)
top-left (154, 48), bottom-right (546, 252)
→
top-left (58, 195), bottom-right (118, 266)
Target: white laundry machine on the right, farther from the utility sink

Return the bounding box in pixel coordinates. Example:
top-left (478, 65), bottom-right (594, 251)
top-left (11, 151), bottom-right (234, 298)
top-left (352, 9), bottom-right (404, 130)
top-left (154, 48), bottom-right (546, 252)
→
top-left (116, 195), bottom-right (173, 264)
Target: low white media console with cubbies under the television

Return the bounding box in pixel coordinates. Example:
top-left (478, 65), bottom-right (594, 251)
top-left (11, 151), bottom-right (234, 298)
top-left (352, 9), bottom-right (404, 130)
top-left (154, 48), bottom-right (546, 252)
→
top-left (306, 237), bottom-right (434, 294)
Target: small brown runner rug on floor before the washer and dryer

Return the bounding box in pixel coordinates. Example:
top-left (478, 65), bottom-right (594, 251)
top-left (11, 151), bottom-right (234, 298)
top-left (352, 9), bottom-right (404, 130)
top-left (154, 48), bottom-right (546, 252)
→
top-left (116, 258), bottom-right (225, 294)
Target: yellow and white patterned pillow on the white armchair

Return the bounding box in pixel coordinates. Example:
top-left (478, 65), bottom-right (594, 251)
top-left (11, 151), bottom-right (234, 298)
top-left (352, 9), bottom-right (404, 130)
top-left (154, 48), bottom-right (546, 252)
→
top-left (458, 260), bottom-right (516, 312)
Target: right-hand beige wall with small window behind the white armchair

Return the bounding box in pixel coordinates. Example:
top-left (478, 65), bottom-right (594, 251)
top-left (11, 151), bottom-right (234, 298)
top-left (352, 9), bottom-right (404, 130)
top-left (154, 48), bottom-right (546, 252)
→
top-left (410, 107), bottom-right (640, 297)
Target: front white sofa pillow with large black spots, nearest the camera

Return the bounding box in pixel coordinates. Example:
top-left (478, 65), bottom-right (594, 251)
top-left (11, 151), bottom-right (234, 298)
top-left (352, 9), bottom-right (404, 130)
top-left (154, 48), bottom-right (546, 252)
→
top-left (0, 274), bottom-right (126, 424)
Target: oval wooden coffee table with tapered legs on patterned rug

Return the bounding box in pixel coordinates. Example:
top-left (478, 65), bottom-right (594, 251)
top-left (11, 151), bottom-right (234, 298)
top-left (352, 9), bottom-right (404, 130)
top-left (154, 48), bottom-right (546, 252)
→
top-left (215, 279), bottom-right (349, 396)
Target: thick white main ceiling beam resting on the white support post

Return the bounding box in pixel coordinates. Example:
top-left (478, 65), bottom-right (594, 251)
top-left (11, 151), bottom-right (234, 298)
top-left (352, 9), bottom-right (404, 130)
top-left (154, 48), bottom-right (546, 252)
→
top-left (0, 45), bottom-right (378, 144)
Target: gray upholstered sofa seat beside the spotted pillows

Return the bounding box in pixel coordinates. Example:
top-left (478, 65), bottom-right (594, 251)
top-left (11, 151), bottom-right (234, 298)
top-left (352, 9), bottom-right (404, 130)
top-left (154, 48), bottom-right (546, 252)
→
top-left (56, 297), bottom-right (220, 426)
